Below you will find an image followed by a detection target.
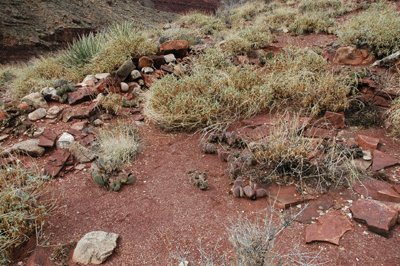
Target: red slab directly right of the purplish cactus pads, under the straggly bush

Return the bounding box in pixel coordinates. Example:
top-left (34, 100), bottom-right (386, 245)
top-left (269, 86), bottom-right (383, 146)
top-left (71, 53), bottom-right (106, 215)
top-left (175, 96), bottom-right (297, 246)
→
top-left (265, 184), bottom-right (314, 209)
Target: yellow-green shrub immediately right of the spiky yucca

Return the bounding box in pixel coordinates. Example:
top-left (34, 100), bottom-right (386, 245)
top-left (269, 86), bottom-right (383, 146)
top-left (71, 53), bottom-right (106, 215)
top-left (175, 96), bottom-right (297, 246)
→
top-left (90, 21), bottom-right (157, 73)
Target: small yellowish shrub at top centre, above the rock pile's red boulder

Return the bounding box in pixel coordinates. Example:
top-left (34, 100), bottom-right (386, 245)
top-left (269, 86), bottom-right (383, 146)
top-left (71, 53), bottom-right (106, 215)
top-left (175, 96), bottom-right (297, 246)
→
top-left (180, 12), bottom-right (225, 35)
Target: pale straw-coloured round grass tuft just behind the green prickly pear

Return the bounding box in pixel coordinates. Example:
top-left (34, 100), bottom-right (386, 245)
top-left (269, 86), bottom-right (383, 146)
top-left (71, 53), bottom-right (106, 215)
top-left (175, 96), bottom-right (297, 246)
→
top-left (97, 121), bottom-right (143, 170)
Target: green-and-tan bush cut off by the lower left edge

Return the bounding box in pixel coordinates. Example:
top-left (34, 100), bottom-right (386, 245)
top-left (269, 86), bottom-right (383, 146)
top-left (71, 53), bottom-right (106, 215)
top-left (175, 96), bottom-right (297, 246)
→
top-left (0, 165), bottom-right (48, 265)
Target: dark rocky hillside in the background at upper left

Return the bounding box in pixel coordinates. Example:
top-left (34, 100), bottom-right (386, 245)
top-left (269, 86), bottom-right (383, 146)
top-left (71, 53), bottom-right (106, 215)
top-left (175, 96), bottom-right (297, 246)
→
top-left (0, 0), bottom-right (179, 63)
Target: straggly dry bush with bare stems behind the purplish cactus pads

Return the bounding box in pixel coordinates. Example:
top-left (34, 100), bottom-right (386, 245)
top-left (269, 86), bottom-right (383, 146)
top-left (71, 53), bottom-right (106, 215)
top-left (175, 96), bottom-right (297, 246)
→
top-left (248, 114), bottom-right (362, 191)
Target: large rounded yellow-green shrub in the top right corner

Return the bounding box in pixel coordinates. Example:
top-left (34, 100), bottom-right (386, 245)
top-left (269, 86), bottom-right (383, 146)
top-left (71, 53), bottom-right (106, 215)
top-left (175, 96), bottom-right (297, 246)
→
top-left (337, 3), bottom-right (400, 57)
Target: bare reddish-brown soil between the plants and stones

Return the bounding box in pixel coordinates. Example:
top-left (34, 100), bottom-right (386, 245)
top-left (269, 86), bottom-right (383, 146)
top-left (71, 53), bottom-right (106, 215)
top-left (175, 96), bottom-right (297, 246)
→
top-left (2, 30), bottom-right (400, 266)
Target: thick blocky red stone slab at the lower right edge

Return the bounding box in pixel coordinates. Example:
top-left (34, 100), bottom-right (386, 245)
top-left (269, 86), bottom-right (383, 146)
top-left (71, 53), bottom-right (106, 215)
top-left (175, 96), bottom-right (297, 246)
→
top-left (350, 199), bottom-right (400, 237)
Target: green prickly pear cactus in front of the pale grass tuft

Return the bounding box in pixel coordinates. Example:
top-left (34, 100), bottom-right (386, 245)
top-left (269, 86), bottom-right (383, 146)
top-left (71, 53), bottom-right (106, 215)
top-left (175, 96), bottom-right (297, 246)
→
top-left (92, 158), bottom-right (136, 191)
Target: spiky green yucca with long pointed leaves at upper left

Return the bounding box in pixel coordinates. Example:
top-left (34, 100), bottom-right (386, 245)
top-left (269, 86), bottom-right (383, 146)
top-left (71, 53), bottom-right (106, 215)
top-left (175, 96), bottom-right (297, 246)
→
top-left (62, 33), bottom-right (104, 70)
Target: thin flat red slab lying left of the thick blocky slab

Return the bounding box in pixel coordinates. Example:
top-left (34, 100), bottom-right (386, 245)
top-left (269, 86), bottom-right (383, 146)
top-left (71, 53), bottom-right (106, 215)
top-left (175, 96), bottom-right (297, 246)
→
top-left (306, 212), bottom-right (353, 245)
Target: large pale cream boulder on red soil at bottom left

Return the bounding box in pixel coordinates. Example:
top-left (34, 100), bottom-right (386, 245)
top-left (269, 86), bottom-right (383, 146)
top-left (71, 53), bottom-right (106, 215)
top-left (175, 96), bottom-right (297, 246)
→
top-left (72, 231), bottom-right (118, 265)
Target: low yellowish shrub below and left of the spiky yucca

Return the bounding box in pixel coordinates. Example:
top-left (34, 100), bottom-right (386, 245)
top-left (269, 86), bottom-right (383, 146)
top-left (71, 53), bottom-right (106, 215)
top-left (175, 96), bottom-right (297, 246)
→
top-left (10, 55), bottom-right (81, 99)
